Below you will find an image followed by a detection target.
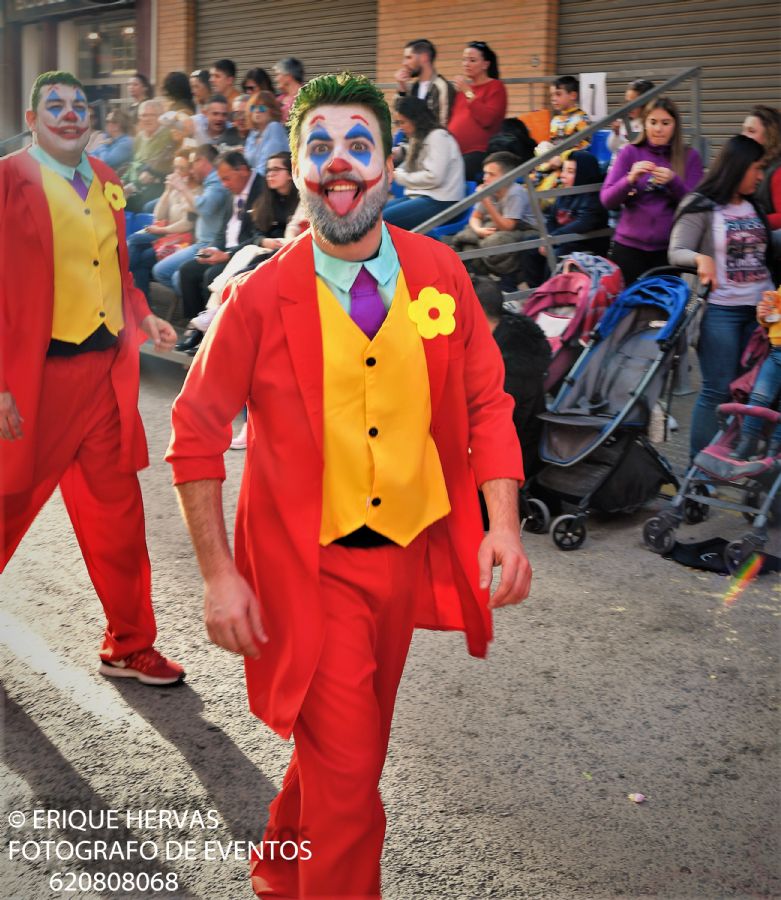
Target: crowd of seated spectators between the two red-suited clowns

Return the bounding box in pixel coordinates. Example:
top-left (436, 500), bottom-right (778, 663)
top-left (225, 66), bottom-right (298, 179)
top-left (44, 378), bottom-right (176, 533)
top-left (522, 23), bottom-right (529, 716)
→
top-left (100, 57), bottom-right (305, 316)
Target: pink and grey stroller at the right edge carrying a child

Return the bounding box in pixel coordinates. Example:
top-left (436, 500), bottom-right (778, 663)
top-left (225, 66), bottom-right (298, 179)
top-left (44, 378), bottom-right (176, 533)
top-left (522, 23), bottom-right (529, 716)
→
top-left (643, 334), bottom-right (781, 573)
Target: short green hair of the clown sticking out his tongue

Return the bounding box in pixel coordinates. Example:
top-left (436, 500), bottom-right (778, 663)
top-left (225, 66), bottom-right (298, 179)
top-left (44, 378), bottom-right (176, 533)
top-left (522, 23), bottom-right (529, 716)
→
top-left (288, 72), bottom-right (393, 163)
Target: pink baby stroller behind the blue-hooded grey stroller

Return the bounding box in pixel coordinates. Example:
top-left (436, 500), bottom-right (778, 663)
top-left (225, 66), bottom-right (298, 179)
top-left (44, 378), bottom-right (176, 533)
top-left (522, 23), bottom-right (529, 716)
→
top-left (523, 252), bottom-right (624, 394)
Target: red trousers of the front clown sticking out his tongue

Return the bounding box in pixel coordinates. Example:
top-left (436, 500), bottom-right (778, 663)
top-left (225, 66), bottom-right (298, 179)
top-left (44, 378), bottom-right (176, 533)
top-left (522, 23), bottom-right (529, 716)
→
top-left (252, 535), bottom-right (426, 900)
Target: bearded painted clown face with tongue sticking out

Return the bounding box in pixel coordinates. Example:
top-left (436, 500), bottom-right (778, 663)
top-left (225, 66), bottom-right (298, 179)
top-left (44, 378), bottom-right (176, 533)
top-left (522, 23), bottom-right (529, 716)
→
top-left (297, 106), bottom-right (388, 244)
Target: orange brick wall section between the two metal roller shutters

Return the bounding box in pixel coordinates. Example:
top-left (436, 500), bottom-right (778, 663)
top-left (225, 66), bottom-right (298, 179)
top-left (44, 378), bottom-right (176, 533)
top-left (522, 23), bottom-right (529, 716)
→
top-left (377, 0), bottom-right (558, 115)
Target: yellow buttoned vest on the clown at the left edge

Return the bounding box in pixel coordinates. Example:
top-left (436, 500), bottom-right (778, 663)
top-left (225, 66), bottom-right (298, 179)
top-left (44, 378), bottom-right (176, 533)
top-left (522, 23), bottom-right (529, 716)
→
top-left (41, 166), bottom-right (124, 344)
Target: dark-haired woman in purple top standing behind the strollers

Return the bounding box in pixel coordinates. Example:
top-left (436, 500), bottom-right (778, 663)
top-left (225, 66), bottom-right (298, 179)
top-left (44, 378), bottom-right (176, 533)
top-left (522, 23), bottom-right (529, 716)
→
top-left (599, 97), bottom-right (702, 285)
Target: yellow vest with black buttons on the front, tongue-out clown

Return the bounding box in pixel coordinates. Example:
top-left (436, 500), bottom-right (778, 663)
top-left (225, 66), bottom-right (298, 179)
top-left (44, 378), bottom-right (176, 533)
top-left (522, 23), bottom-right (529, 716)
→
top-left (317, 272), bottom-right (450, 547)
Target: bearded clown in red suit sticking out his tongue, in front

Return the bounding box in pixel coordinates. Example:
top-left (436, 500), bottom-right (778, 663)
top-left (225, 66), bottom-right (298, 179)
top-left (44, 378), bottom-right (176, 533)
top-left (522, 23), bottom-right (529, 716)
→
top-left (167, 73), bottom-right (531, 898)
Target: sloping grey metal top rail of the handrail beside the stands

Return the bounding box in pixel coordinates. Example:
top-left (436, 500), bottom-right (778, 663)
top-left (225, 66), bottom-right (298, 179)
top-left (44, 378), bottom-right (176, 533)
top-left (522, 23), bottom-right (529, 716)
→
top-left (411, 66), bottom-right (701, 234)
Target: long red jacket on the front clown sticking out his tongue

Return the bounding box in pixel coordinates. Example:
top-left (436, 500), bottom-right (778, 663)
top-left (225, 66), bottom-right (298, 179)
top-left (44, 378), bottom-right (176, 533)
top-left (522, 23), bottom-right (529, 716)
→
top-left (166, 227), bottom-right (523, 737)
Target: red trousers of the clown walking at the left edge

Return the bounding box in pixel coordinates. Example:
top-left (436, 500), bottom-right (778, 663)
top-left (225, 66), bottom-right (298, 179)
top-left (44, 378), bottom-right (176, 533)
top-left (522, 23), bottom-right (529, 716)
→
top-left (0, 350), bottom-right (156, 659)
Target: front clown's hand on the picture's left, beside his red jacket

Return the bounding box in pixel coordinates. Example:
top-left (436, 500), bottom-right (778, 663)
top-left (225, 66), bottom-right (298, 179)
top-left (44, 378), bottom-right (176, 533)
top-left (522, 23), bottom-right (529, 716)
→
top-left (204, 566), bottom-right (268, 659)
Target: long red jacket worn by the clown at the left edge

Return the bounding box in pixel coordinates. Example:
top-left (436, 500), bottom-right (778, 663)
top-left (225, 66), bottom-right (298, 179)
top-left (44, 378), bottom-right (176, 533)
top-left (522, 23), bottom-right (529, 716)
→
top-left (0, 149), bottom-right (150, 494)
